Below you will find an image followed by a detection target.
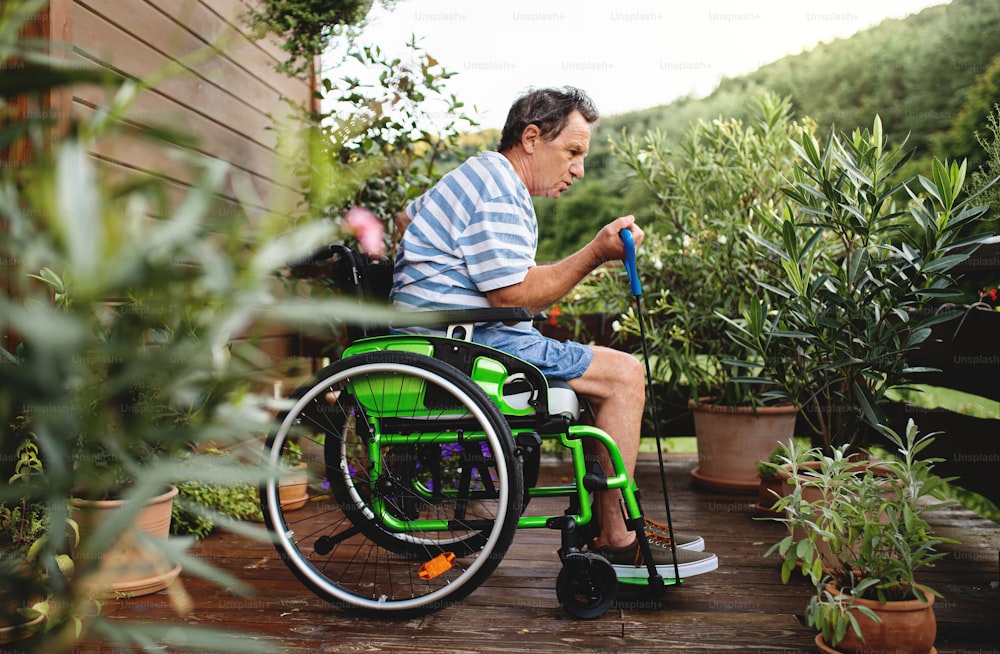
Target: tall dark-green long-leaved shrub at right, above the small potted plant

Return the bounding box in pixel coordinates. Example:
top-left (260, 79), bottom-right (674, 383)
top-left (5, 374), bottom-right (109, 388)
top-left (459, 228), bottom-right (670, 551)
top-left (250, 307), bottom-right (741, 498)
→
top-left (728, 117), bottom-right (991, 453)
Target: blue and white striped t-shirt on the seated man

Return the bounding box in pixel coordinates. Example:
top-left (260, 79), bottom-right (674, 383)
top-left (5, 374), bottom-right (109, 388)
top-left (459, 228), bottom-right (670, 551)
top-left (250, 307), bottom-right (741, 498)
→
top-left (392, 152), bottom-right (538, 318)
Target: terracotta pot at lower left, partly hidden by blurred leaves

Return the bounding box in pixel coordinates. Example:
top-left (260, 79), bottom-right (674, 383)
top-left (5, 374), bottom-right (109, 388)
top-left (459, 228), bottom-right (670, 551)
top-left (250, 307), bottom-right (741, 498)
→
top-left (73, 486), bottom-right (181, 596)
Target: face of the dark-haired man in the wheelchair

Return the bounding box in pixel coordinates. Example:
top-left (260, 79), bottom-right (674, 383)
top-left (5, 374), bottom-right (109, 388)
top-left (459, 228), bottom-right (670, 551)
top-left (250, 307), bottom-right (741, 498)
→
top-left (528, 111), bottom-right (590, 198)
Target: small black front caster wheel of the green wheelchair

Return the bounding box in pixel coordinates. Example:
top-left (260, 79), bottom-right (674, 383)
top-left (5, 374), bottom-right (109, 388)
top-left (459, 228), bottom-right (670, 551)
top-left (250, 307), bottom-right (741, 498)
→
top-left (556, 552), bottom-right (618, 620)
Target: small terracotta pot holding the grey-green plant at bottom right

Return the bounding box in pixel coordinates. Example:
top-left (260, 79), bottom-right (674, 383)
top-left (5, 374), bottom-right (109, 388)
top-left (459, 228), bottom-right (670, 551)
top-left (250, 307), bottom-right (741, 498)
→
top-left (816, 589), bottom-right (937, 654)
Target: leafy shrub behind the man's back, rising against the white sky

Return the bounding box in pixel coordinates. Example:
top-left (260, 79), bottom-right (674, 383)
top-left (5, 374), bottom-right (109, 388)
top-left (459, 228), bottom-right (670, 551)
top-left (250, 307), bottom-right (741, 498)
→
top-left (282, 37), bottom-right (477, 254)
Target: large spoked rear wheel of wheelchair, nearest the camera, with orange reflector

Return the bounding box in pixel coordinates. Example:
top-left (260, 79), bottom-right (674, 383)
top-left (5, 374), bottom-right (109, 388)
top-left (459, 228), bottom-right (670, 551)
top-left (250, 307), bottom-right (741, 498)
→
top-left (261, 351), bottom-right (523, 615)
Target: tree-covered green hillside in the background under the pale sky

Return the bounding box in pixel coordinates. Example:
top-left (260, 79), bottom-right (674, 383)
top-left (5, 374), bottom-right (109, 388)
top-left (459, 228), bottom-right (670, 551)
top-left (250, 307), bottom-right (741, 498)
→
top-left (536, 0), bottom-right (1000, 260)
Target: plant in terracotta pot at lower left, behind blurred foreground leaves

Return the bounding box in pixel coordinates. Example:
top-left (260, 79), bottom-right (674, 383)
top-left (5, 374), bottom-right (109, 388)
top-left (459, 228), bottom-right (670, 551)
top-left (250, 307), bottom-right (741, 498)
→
top-left (19, 266), bottom-right (194, 597)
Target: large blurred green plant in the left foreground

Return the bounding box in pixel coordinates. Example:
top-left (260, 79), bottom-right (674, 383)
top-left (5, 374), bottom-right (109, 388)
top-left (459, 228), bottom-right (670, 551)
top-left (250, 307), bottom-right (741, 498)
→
top-left (0, 119), bottom-right (356, 651)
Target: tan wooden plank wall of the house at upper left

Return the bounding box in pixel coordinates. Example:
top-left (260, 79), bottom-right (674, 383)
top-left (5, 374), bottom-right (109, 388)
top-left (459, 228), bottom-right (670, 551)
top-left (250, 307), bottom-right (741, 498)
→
top-left (61, 0), bottom-right (314, 380)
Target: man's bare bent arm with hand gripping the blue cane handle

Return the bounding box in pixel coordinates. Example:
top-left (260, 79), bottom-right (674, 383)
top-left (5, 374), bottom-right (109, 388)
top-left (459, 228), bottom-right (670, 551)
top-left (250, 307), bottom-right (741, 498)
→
top-left (487, 216), bottom-right (643, 313)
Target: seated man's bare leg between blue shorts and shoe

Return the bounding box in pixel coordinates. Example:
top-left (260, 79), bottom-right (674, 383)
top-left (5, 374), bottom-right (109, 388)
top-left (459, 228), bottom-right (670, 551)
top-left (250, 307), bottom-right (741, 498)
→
top-left (569, 347), bottom-right (646, 547)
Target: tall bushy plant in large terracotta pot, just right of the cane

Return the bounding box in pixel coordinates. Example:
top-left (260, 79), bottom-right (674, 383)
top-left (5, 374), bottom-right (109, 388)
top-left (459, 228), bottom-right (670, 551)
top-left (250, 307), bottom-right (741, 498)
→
top-left (588, 96), bottom-right (811, 493)
